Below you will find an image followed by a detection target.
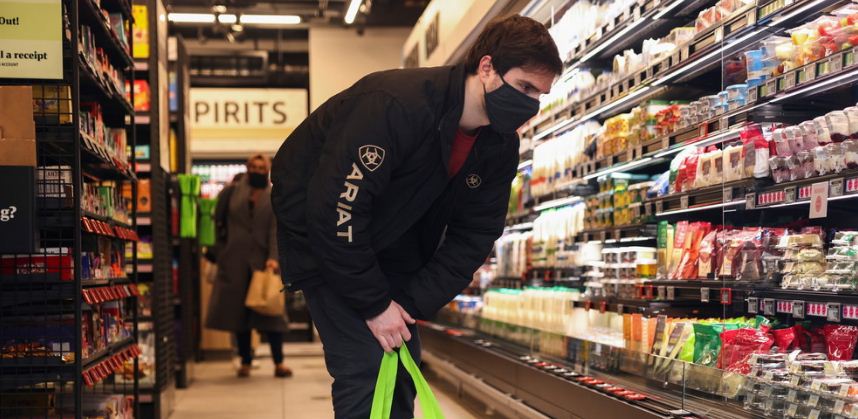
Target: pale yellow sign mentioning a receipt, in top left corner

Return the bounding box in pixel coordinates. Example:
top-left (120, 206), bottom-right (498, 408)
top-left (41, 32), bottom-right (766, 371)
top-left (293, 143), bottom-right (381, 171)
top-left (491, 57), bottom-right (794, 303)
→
top-left (0, 0), bottom-right (63, 79)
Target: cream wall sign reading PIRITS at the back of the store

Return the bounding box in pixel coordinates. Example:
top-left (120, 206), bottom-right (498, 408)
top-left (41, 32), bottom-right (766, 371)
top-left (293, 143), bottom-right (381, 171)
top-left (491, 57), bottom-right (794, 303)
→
top-left (191, 88), bottom-right (307, 141)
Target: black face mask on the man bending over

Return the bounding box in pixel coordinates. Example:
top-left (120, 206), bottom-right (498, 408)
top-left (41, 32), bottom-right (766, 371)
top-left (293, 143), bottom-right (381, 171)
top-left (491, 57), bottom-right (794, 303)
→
top-left (483, 77), bottom-right (539, 134)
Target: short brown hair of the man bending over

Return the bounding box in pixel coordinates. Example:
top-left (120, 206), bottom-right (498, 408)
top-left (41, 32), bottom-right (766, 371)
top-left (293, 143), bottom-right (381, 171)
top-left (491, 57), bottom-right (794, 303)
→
top-left (465, 15), bottom-right (563, 75)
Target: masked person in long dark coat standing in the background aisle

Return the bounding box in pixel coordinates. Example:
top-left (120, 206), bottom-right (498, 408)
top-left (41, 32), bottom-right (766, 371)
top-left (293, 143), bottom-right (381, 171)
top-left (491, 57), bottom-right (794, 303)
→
top-left (206, 155), bottom-right (292, 377)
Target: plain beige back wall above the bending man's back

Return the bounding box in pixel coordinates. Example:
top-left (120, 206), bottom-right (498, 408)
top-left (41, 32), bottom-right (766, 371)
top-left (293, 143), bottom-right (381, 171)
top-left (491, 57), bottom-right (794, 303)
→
top-left (309, 27), bottom-right (410, 112)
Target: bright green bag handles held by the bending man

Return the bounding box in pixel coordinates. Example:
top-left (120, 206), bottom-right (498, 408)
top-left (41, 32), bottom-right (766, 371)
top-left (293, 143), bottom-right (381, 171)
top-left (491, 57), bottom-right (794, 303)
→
top-left (369, 345), bottom-right (444, 419)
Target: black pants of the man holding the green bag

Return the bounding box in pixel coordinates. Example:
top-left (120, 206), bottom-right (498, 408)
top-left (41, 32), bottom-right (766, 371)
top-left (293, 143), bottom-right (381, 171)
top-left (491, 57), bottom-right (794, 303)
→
top-left (304, 286), bottom-right (420, 419)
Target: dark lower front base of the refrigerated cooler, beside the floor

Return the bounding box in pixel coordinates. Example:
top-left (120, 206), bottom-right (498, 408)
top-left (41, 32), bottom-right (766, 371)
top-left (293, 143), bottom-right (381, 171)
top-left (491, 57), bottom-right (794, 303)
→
top-left (420, 322), bottom-right (760, 419)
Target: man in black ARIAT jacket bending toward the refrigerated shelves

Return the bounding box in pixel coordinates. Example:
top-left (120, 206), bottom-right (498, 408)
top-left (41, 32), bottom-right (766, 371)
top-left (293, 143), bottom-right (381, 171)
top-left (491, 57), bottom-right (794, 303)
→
top-left (272, 16), bottom-right (563, 419)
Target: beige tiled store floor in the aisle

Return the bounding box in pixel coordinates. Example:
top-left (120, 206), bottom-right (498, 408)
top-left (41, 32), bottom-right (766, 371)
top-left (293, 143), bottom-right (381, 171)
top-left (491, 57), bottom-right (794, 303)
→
top-left (170, 343), bottom-right (475, 419)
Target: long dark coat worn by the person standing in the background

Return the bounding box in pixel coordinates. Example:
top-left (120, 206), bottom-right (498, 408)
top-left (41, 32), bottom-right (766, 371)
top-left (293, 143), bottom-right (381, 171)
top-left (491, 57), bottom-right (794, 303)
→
top-left (206, 178), bottom-right (288, 332)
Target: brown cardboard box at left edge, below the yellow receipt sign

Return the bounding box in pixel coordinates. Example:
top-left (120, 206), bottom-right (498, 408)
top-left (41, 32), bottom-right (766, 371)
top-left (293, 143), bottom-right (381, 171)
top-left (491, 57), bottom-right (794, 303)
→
top-left (0, 86), bottom-right (36, 167)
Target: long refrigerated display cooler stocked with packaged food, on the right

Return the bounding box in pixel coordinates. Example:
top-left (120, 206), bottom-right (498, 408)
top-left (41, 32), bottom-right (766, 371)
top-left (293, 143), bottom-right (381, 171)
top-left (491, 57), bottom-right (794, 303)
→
top-left (422, 0), bottom-right (858, 418)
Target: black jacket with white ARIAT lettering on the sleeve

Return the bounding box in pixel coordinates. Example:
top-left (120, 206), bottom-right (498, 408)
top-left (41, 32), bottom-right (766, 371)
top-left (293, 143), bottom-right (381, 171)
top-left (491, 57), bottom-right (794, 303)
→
top-left (271, 65), bottom-right (519, 318)
